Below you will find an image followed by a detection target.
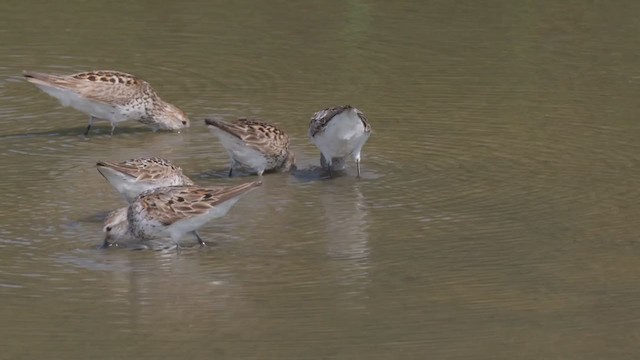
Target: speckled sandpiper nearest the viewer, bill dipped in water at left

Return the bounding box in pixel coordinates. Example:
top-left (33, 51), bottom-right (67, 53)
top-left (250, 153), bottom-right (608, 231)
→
top-left (104, 181), bottom-right (262, 249)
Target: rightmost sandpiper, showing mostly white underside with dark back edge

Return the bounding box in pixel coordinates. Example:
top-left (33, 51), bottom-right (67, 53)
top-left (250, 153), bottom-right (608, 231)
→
top-left (309, 105), bottom-right (371, 177)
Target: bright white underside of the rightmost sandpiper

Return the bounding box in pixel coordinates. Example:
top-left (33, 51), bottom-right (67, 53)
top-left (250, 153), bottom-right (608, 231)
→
top-left (311, 109), bottom-right (369, 166)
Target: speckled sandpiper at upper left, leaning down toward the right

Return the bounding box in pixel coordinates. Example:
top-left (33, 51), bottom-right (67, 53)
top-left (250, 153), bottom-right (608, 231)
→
top-left (24, 70), bottom-right (189, 136)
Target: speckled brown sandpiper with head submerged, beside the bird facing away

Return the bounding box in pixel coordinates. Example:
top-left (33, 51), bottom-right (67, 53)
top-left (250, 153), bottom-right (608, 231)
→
top-left (204, 119), bottom-right (295, 176)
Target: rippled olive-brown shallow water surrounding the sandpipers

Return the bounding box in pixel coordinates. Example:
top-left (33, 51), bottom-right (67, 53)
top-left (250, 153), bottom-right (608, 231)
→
top-left (0, 0), bottom-right (640, 359)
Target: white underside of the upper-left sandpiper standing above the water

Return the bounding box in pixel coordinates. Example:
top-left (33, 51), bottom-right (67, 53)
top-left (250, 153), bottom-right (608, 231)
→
top-left (34, 82), bottom-right (134, 124)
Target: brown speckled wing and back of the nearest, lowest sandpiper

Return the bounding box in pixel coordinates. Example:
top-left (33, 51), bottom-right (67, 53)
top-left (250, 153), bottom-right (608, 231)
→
top-left (136, 181), bottom-right (262, 226)
